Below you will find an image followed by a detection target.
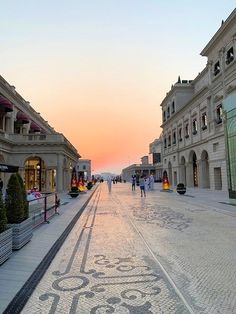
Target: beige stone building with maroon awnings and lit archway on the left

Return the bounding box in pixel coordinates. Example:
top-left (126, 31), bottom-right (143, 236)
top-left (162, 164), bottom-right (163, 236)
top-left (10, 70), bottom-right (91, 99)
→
top-left (0, 76), bottom-right (80, 192)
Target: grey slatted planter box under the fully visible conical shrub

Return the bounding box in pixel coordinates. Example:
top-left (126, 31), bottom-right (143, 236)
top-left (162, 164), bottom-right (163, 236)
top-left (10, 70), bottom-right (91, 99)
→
top-left (9, 218), bottom-right (33, 250)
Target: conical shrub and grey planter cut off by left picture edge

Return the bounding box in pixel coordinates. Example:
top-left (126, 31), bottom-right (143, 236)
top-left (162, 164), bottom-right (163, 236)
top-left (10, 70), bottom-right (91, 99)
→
top-left (0, 193), bottom-right (12, 265)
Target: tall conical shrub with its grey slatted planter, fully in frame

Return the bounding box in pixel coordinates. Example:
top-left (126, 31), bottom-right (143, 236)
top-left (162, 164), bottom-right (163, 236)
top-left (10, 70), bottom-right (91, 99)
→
top-left (5, 173), bottom-right (33, 250)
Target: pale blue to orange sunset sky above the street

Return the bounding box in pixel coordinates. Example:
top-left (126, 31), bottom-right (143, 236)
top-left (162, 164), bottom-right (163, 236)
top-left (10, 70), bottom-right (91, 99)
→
top-left (0, 0), bottom-right (236, 174)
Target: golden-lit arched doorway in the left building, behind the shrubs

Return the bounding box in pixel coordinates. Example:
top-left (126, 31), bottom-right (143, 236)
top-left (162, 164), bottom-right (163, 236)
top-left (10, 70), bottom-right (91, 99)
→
top-left (24, 157), bottom-right (46, 192)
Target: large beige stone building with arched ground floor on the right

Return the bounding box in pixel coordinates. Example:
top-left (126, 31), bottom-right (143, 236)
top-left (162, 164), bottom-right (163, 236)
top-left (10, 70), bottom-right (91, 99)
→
top-left (161, 9), bottom-right (236, 190)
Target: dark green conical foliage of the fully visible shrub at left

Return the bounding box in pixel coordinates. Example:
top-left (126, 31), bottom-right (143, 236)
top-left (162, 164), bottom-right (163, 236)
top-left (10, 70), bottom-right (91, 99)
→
top-left (5, 173), bottom-right (24, 224)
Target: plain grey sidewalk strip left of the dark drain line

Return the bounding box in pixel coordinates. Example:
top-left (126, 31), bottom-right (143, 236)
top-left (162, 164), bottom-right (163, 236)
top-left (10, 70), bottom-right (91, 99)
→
top-left (0, 191), bottom-right (97, 313)
